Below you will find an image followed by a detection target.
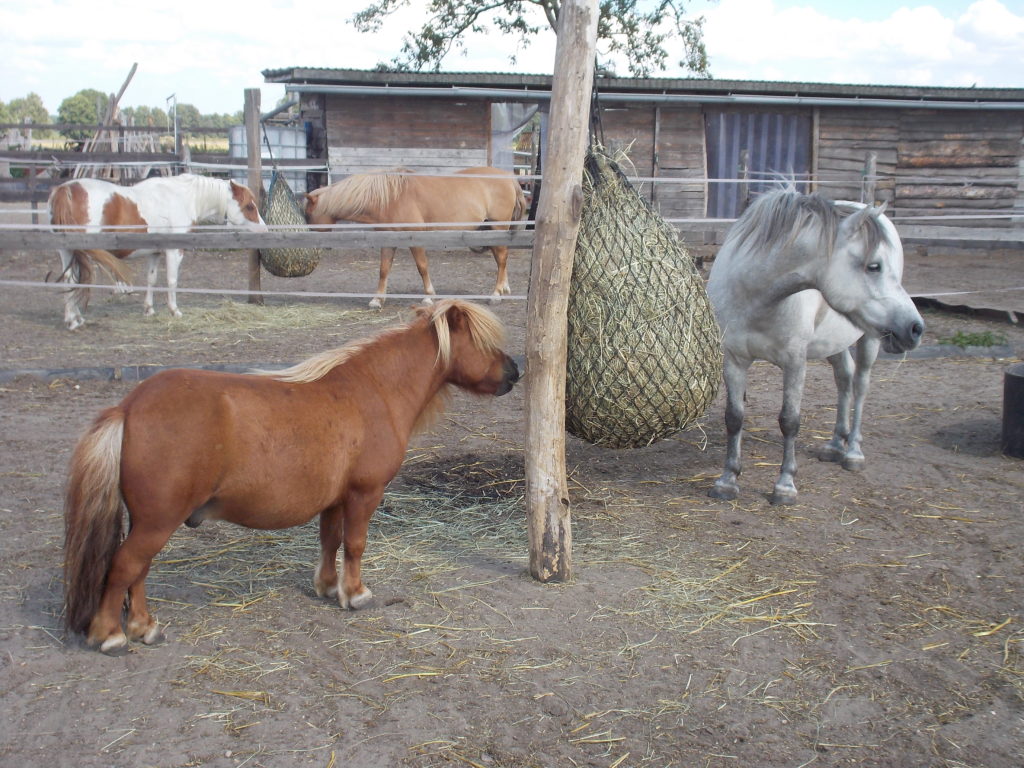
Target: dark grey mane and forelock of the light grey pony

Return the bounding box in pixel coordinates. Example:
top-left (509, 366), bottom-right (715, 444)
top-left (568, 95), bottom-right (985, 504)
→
top-left (726, 185), bottom-right (886, 257)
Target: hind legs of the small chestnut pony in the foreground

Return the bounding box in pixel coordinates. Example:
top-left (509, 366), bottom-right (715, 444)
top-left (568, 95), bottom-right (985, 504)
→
top-left (87, 520), bottom-right (174, 655)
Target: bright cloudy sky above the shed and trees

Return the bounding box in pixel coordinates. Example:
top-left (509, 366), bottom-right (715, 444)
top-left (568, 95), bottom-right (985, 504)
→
top-left (0, 0), bottom-right (1024, 114)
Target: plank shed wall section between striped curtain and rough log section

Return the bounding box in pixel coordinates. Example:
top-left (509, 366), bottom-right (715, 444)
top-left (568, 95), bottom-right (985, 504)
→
top-left (814, 109), bottom-right (899, 205)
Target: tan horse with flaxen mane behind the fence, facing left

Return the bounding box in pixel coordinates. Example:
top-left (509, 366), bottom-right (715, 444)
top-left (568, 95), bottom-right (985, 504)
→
top-left (306, 167), bottom-right (526, 309)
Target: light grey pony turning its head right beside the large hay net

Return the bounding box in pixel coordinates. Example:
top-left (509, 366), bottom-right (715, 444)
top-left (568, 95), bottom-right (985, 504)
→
top-left (708, 188), bottom-right (925, 504)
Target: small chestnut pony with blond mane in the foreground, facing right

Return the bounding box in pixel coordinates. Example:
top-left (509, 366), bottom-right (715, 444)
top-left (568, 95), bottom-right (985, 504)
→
top-left (65, 300), bottom-right (519, 653)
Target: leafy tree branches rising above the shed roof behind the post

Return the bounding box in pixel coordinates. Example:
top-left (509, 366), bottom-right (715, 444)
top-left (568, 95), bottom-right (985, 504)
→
top-left (352, 0), bottom-right (709, 77)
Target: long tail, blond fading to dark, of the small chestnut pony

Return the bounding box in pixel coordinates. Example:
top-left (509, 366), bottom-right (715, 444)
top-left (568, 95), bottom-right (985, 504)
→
top-left (65, 408), bottom-right (124, 633)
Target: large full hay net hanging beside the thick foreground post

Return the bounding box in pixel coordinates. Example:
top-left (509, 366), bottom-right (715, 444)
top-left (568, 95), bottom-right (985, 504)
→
top-left (565, 150), bottom-right (722, 447)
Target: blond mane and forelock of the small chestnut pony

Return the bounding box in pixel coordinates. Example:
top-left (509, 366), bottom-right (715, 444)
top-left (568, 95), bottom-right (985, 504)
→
top-left (255, 299), bottom-right (505, 383)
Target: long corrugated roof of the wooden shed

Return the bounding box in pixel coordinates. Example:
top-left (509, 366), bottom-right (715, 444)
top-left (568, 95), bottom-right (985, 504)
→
top-left (262, 67), bottom-right (1024, 102)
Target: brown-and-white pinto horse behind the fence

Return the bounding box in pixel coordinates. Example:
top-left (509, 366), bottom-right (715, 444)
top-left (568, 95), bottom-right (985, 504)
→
top-left (49, 173), bottom-right (266, 331)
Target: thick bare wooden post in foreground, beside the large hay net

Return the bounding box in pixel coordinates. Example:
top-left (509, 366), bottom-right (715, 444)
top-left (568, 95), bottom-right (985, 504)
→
top-left (526, 0), bottom-right (597, 582)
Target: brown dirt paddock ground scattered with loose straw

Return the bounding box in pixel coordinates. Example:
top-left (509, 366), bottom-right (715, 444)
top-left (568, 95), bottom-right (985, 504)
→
top-left (0, 236), bottom-right (1024, 768)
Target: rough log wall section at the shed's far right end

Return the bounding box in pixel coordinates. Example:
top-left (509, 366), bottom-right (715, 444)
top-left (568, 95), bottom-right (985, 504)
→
top-left (896, 110), bottom-right (1024, 226)
